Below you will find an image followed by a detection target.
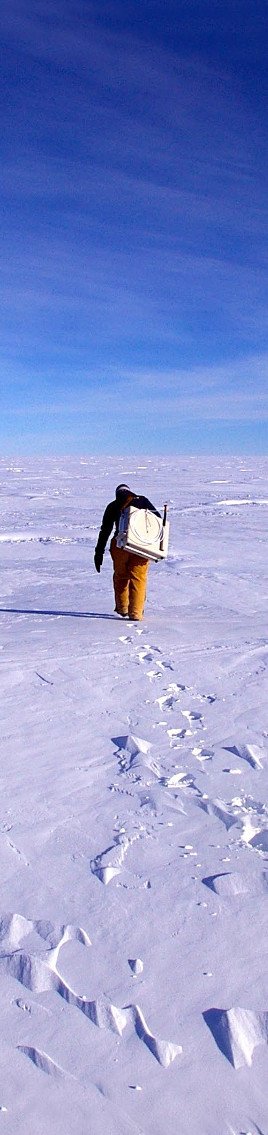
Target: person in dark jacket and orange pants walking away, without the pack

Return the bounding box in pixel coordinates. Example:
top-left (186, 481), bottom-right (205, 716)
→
top-left (94, 484), bottom-right (160, 622)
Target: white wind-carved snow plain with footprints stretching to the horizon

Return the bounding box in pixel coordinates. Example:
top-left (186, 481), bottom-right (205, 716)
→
top-left (0, 457), bottom-right (268, 1135)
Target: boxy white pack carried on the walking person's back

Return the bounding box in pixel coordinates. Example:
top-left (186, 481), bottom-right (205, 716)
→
top-left (116, 504), bottom-right (169, 563)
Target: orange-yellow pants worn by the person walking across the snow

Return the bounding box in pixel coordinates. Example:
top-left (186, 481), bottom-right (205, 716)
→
top-left (110, 536), bottom-right (149, 619)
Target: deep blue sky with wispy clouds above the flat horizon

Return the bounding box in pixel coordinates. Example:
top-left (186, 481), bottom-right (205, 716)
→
top-left (0, 0), bottom-right (268, 454)
